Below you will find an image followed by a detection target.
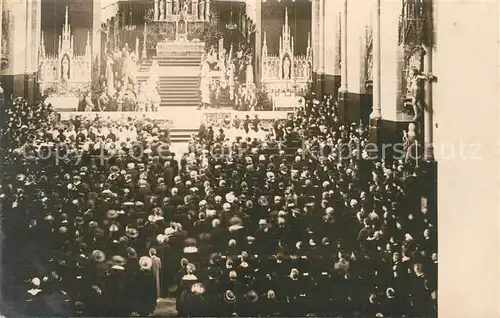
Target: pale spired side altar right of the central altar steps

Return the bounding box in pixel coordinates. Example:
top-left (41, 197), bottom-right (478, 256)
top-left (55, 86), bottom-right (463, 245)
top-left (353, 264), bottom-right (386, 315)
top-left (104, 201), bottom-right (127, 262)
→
top-left (261, 9), bottom-right (312, 94)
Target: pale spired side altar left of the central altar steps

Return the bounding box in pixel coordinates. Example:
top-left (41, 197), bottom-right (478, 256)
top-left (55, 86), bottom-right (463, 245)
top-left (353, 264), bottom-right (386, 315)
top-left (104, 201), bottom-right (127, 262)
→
top-left (39, 7), bottom-right (92, 96)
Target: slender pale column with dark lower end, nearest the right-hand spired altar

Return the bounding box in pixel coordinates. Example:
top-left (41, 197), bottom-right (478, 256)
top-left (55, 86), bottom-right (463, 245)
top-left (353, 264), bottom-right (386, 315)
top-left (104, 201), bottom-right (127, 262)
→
top-left (338, 0), bottom-right (348, 122)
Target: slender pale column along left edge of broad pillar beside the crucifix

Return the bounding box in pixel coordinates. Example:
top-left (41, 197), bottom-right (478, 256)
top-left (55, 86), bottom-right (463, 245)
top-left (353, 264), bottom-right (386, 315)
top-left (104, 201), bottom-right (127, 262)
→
top-left (370, 0), bottom-right (382, 119)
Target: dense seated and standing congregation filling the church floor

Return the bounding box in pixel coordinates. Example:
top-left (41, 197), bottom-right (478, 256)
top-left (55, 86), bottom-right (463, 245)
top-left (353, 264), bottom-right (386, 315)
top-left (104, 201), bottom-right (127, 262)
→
top-left (0, 90), bottom-right (437, 317)
